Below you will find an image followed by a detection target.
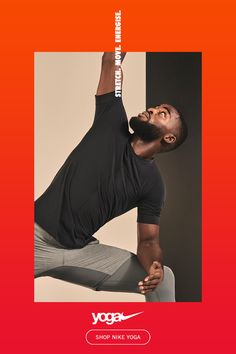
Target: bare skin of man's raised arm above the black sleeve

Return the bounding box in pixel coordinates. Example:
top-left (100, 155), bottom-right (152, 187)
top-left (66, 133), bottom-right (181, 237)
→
top-left (96, 52), bottom-right (126, 95)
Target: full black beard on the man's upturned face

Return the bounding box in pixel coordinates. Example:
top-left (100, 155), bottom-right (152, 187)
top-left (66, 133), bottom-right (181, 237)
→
top-left (129, 117), bottom-right (163, 142)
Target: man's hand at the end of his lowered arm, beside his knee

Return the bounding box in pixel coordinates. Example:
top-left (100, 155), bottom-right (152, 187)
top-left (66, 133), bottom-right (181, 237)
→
top-left (138, 261), bottom-right (164, 294)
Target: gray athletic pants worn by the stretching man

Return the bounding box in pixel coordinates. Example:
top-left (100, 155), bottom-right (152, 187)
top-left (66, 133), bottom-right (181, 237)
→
top-left (34, 223), bottom-right (175, 302)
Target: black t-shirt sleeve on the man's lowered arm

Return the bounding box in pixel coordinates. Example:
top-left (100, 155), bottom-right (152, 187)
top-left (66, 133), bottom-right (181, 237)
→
top-left (137, 176), bottom-right (165, 225)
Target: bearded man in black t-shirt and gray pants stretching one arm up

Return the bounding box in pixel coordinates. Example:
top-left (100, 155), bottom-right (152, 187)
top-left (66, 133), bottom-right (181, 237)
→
top-left (35, 53), bottom-right (187, 302)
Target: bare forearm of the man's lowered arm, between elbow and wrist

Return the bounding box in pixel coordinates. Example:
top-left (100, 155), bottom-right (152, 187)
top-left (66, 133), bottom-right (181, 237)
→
top-left (137, 240), bottom-right (163, 273)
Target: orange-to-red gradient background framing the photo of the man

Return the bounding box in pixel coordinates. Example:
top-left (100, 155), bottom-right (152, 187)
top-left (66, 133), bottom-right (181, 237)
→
top-left (0, 0), bottom-right (236, 354)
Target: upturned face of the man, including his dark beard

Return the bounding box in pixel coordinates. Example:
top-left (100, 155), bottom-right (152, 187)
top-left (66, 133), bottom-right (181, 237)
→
top-left (129, 104), bottom-right (179, 142)
